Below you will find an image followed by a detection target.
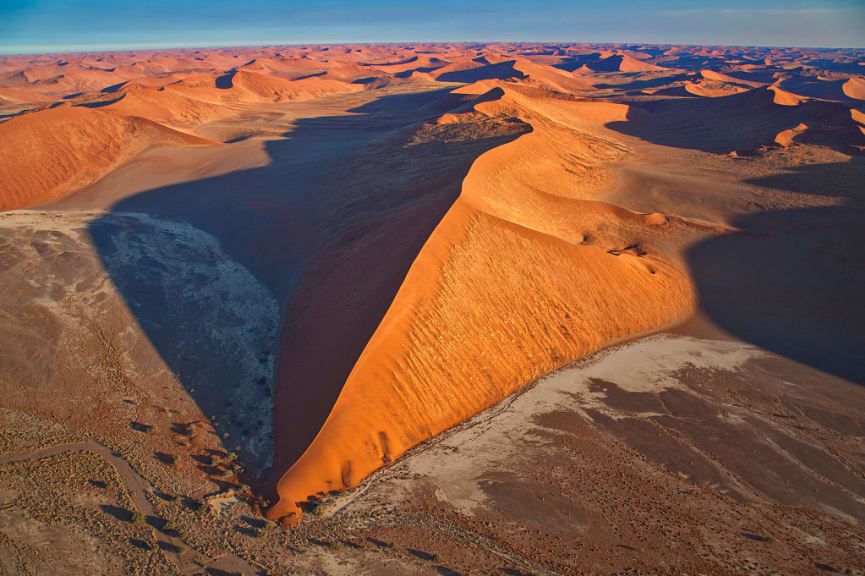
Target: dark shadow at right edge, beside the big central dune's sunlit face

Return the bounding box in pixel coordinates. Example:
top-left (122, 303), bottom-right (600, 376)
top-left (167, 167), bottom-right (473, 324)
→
top-left (687, 158), bottom-right (865, 384)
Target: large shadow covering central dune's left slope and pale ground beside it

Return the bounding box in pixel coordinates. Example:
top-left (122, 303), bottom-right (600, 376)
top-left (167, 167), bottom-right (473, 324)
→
top-left (89, 89), bottom-right (518, 476)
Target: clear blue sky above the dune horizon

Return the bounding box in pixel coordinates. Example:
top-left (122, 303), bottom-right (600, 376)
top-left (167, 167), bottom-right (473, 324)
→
top-left (0, 0), bottom-right (865, 53)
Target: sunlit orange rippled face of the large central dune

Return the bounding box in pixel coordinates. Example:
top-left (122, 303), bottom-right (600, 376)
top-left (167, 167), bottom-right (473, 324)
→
top-left (268, 84), bottom-right (693, 523)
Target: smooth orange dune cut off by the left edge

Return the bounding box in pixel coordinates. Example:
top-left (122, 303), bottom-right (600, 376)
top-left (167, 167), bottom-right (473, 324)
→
top-left (0, 106), bottom-right (213, 210)
